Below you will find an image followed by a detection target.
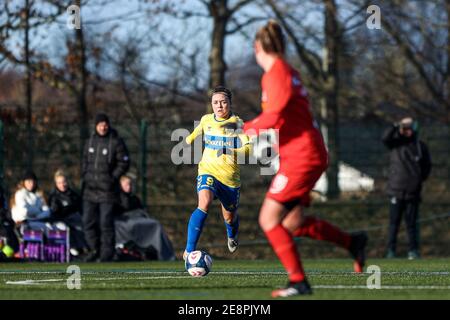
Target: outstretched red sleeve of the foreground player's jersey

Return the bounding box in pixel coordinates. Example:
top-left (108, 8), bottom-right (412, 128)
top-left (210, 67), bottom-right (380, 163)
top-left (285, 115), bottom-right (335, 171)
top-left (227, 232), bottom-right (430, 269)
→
top-left (244, 69), bottom-right (292, 134)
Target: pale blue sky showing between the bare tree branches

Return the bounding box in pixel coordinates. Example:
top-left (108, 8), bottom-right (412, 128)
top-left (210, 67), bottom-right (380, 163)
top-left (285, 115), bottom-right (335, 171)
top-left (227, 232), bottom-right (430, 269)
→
top-left (0, 0), bottom-right (376, 89)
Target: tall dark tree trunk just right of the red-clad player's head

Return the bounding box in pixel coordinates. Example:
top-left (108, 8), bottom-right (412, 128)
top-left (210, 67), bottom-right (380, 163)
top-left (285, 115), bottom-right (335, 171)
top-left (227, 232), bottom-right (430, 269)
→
top-left (323, 0), bottom-right (340, 199)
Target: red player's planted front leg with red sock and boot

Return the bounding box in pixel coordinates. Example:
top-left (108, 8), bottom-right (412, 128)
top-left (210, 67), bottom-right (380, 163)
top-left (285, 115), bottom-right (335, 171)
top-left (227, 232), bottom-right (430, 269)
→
top-left (259, 197), bottom-right (312, 297)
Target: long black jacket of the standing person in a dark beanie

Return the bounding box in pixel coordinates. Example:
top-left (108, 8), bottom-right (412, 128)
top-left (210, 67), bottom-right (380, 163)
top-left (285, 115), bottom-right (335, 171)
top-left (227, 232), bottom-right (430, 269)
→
top-left (83, 128), bottom-right (130, 203)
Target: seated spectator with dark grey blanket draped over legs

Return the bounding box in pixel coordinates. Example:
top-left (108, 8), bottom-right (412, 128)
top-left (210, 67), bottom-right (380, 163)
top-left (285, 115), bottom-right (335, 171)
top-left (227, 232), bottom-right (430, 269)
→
top-left (114, 175), bottom-right (175, 260)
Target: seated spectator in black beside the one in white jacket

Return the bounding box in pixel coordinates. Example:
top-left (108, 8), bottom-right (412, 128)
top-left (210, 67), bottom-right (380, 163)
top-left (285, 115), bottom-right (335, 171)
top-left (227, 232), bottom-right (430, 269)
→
top-left (48, 170), bottom-right (87, 256)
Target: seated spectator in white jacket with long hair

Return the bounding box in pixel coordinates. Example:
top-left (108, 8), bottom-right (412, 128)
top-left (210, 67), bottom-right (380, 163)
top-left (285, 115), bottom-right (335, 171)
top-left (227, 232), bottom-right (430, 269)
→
top-left (10, 171), bottom-right (54, 231)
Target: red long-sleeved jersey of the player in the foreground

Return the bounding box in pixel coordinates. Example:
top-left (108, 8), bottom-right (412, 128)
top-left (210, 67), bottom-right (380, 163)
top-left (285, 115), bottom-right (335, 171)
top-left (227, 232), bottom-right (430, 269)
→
top-left (244, 58), bottom-right (328, 171)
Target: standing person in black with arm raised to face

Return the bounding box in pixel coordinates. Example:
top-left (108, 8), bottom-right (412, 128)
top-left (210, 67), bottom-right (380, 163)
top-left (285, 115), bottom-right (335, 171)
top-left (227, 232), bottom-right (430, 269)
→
top-left (383, 117), bottom-right (431, 259)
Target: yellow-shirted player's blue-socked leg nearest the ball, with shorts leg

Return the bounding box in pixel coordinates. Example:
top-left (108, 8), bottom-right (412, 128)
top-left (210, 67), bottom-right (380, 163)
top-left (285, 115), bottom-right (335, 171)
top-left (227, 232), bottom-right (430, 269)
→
top-left (183, 175), bottom-right (215, 259)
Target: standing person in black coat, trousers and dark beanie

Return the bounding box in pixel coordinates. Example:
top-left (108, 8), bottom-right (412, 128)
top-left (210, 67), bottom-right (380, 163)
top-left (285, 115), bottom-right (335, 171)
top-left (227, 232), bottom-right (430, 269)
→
top-left (82, 113), bottom-right (130, 262)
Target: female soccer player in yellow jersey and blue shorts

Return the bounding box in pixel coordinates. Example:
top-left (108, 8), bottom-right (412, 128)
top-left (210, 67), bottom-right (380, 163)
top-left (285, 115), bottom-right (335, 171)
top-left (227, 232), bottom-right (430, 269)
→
top-left (183, 86), bottom-right (250, 260)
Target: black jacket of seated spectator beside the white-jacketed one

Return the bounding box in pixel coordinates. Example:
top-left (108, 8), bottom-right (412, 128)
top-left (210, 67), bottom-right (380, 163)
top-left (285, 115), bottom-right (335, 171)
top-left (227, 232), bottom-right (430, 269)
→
top-left (48, 188), bottom-right (81, 221)
